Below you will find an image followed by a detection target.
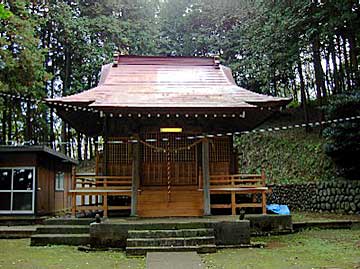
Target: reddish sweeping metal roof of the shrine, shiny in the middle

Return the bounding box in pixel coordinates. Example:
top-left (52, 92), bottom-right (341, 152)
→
top-left (48, 56), bottom-right (289, 112)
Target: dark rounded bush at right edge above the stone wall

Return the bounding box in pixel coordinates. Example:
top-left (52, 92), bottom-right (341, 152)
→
top-left (323, 93), bottom-right (360, 179)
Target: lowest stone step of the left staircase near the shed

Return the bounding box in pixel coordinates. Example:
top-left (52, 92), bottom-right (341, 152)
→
top-left (30, 234), bottom-right (90, 246)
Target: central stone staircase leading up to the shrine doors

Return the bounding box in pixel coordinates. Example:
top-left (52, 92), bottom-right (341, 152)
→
top-left (126, 228), bottom-right (216, 256)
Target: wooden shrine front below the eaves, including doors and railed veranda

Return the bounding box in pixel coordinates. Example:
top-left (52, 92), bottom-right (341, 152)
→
top-left (70, 136), bottom-right (267, 217)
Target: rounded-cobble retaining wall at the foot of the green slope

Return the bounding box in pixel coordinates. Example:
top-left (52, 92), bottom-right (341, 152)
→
top-left (267, 180), bottom-right (360, 214)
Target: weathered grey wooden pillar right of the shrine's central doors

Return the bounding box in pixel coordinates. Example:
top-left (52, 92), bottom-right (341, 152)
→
top-left (202, 139), bottom-right (211, 216)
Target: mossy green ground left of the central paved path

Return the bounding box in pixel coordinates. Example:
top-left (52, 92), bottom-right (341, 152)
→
top-left (0, 239), bottom-right (145, 269)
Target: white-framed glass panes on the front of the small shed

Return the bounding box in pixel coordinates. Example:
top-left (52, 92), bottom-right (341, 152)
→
top-left (0, 167), bottom-right (35, 214)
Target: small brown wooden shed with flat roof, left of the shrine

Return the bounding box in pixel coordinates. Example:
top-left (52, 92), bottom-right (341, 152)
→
top-left (0, 146), bottom-right (76, 215)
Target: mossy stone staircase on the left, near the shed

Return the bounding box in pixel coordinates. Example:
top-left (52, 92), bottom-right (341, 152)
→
top-left (30, 218), bottom-right (94, 246)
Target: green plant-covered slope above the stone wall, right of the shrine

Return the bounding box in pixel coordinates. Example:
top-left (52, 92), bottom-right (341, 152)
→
top-left (236, 131), bottom-right (335, 183)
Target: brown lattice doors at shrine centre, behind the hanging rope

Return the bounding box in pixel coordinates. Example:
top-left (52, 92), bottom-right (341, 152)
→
top-left (141, 133), bottom-right (198, 186)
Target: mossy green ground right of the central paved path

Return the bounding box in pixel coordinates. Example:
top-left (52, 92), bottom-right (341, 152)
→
top-left (203, 230), bottom-right (360, 269)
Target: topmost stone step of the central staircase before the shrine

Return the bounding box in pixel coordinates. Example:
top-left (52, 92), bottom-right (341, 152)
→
top-left (128, 229), bottom-right (214, 238)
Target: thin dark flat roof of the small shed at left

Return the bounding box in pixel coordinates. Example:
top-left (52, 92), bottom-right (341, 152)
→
top-left (0, 146), bottom-right (78, 164)
